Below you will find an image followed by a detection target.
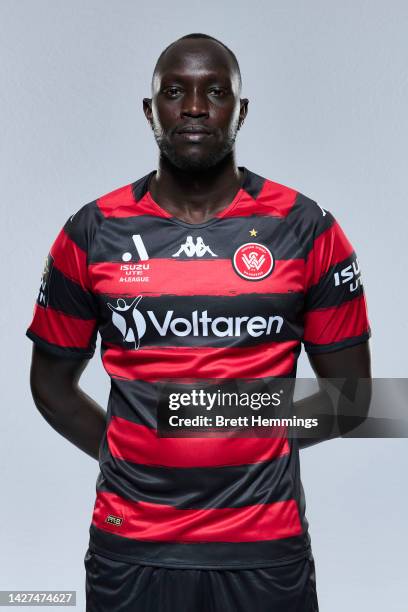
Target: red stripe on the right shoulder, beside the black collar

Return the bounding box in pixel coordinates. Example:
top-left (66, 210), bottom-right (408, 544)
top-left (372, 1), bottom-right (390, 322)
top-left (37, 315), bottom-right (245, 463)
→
top-left (220, 179), bottom-right (298, 217)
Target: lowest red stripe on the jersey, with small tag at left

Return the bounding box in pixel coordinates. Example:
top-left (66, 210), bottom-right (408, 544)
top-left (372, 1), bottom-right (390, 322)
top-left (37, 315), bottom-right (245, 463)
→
top-left (92, 491), bottom-right (302, 542)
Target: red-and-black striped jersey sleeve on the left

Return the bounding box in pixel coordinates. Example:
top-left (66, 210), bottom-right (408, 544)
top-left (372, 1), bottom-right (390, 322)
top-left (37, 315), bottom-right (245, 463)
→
top-left (26, 204), bottom-right (98, 358)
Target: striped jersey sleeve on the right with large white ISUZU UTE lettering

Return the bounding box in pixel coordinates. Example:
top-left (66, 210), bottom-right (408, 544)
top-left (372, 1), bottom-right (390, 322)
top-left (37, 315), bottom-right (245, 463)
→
top-left (303, 205), bottom-right (371, 353)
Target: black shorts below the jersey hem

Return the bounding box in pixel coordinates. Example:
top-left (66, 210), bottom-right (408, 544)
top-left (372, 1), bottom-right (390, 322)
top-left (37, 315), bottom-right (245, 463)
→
top-left (84, 549), bottom-right (319, 612)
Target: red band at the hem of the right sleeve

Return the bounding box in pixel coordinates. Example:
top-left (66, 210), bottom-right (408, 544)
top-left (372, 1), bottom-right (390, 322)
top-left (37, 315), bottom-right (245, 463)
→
top-left (304, 294), bottom-right (369, 344)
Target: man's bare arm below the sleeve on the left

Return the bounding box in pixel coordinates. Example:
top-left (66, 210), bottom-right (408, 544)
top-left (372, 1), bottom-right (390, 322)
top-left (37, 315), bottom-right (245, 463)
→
top-left (30, 345), bottom-right (106, 460)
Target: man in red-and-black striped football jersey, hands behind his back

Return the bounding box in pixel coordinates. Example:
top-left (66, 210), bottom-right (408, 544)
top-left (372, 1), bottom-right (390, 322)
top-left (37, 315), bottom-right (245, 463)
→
top-left (27, 34), bottom-right (370, 612)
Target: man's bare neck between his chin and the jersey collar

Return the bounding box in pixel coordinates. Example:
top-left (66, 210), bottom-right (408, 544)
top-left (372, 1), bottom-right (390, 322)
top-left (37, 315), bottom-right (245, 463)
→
top-left (149, 152), bottom-right (243, 223)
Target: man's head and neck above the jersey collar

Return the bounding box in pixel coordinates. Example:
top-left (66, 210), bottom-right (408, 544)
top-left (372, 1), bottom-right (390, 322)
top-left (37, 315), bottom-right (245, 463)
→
top-left (143, 39), bottom-right (248, 223)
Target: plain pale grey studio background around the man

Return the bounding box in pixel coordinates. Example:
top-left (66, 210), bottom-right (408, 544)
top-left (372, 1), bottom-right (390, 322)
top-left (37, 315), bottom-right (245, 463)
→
top-left (0, 0), bottom-right (408, 612)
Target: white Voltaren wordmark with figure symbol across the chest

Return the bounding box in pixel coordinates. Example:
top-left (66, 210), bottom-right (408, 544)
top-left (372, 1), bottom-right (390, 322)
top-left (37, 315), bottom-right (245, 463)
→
top-left (107, 295), bottom-right (284, 350)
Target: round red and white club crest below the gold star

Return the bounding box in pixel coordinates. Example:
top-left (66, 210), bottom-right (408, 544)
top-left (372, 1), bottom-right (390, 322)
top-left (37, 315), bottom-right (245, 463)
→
top-left (232, 242), bottom-right (275, 281)
